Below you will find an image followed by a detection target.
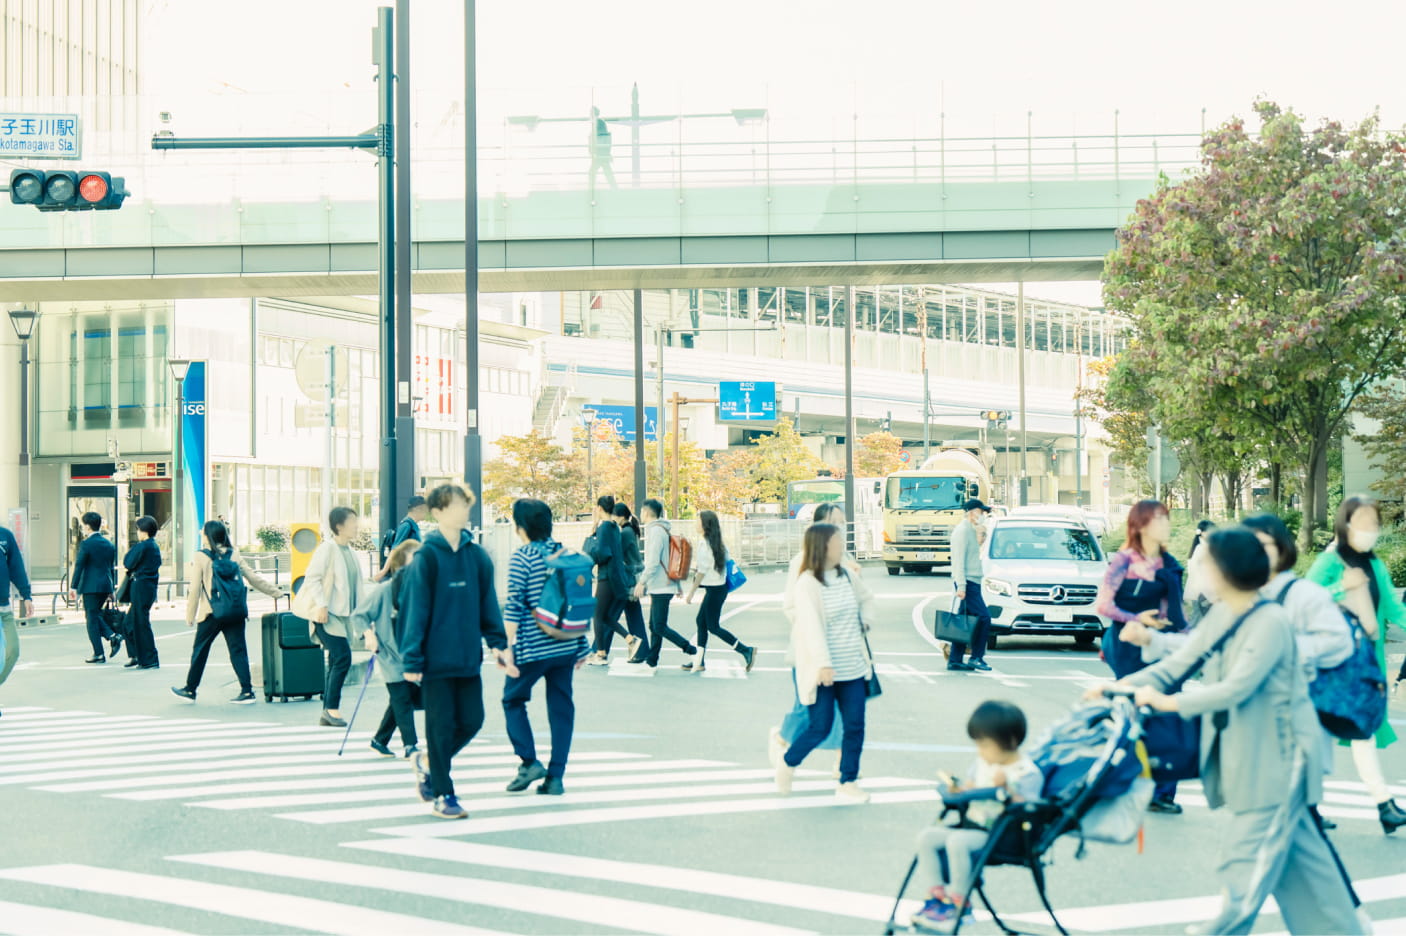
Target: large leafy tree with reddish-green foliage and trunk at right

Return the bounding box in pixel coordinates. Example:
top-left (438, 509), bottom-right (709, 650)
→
top-left (1104, 101), bottom-right (1406, 542)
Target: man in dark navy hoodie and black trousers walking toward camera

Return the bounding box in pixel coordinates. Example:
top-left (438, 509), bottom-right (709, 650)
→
top-left (401, 483), bottom-right (517, 819)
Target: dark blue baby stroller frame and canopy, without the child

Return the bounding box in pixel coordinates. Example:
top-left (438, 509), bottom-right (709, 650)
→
top-left (884, 697), bottom-right (1153, 936)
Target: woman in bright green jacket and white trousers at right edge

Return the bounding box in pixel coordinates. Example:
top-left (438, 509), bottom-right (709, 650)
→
top-left (1305, 498), bottom-right (1406, 835)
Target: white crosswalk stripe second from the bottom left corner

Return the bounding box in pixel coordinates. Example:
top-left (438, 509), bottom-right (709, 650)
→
top-left (0, 864), bottom-right (503, 936)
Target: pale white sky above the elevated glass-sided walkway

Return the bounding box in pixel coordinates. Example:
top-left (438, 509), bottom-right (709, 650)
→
top-left (143, 0), bottom-right (1406, 302)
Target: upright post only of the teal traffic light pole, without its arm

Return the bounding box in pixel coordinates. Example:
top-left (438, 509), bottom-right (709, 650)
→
top-left (373, 7), bottom-right (396, 539)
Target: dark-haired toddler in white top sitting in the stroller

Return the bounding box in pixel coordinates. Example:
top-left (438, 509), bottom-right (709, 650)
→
top-left (911, 701), bottom-right (1045, 933)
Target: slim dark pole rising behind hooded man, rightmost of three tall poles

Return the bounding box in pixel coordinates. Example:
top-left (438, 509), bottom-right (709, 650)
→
top-left (464, 0), bottom-right (484, 528)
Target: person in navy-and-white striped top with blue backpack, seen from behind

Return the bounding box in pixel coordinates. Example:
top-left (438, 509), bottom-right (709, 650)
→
top-left (503, 499), bottom-right (595, 797)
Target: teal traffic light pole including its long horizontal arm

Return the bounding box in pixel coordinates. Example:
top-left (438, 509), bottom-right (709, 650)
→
top-left (152, 0), bottom-right (404, 539)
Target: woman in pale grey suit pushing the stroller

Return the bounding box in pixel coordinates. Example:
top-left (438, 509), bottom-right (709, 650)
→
top-left (1094, 527), bottom-right (1362, 935)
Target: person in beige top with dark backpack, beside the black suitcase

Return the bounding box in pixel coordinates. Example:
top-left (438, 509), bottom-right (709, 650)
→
top-left (172, 520), bottom-right (287, 706)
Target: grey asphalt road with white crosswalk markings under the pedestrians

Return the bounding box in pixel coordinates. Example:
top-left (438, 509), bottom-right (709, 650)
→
top-left (0, 571), bottom-right (1406, 936)
